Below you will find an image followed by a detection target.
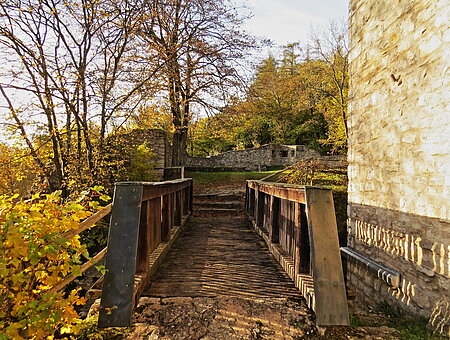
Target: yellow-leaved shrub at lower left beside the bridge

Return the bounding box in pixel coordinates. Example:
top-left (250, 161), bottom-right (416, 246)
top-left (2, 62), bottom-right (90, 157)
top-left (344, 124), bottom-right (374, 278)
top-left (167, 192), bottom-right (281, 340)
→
top-left (0, 192), bottom-right (97, 339)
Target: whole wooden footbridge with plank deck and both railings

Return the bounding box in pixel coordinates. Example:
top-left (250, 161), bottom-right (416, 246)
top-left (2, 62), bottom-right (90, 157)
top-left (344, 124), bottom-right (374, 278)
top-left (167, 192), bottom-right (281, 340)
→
top-left (64, 179), bottom-right (348, 327)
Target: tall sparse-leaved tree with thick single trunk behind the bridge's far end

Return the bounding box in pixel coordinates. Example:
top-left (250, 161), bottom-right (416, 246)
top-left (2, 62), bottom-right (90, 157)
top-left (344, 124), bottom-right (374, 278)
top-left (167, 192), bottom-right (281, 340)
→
top-left (141, 0), bottom-right (254, 165)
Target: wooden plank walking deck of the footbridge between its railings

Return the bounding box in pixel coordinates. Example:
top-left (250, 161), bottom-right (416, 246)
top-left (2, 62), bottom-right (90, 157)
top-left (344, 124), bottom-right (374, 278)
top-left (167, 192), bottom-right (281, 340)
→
top-left (142, 213), bottom-right (301, 299)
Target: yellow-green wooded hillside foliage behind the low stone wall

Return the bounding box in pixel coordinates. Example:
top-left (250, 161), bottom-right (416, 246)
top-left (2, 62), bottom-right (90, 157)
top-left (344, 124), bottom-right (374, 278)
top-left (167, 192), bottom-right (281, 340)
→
top-left (189, 30), bottom-right (348, 155)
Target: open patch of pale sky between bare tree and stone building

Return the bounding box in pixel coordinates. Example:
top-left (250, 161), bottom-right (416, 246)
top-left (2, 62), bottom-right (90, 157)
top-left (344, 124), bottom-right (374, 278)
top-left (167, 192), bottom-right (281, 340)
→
top-left (242, 0), bottom-right (348, 45)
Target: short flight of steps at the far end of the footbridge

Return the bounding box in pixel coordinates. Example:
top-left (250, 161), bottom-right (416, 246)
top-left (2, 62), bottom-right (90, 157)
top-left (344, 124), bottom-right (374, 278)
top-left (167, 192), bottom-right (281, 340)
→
top-left (193, 193), bottom-right (244, 217)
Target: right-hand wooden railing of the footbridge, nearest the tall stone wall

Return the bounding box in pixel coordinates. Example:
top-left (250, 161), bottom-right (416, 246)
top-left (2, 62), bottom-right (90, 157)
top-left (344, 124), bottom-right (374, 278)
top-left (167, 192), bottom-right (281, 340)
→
top-left (245, 181), bottom-right (349, 325)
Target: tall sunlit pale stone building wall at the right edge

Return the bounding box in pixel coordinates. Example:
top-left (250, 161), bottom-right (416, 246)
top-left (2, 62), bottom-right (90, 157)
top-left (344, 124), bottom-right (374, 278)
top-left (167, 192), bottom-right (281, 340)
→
top-left (347, 0), bottom-right (450, 332)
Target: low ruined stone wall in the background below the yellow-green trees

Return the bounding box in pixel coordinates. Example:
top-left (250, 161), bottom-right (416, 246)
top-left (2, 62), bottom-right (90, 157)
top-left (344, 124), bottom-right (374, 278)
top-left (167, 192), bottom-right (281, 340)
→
top-left (184, 144), bottom-right (345, 171)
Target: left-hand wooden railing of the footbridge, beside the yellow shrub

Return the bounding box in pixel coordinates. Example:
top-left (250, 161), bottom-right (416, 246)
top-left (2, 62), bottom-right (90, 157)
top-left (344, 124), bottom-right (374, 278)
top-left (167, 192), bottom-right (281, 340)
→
top-left (98, 179), bottom-right (193, 327)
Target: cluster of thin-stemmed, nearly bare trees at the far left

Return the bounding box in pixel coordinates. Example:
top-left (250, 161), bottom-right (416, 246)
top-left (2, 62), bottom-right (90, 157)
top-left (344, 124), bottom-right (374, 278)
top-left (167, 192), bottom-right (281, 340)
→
top-left (0, 0), bottom-right (159, 193)
